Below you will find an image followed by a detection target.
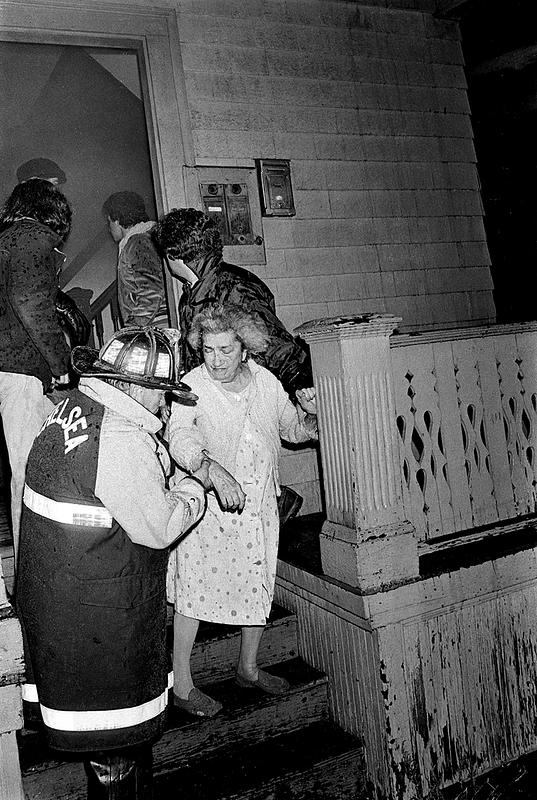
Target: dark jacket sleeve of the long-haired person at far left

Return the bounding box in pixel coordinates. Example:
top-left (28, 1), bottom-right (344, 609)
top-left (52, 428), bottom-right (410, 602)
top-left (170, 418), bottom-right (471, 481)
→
top-left (7, 231), bottom-right (70, 378)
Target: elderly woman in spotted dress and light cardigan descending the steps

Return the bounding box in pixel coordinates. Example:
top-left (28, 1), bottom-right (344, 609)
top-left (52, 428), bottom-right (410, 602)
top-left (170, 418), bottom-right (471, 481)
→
top-left (164, 304), bottom-right (317, 716)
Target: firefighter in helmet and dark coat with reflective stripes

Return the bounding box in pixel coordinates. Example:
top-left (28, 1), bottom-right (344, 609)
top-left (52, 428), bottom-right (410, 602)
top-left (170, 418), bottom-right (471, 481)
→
top-left (16, 328), bottom-right (207, 800)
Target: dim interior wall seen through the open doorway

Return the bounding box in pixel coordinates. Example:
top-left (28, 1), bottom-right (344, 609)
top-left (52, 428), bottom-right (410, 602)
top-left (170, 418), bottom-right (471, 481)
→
top-left (0, 42), bottom-right (155, 304)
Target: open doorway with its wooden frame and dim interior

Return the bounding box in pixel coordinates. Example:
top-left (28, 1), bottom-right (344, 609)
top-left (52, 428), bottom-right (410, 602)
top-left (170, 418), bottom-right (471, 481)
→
top-left (0, 0), bottom-right (194, 583)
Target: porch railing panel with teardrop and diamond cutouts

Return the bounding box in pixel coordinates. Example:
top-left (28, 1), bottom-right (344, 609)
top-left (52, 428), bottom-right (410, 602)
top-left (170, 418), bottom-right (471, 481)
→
top-left (390, 323), bottom-right (537, 541)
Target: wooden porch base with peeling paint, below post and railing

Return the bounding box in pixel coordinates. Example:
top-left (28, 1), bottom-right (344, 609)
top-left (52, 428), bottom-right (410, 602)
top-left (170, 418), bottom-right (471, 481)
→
top-left (277, 549), bottom-right (537, 800)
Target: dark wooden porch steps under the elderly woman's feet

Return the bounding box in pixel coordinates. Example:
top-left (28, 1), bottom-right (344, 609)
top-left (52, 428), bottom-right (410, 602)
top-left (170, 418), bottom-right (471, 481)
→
top-left (19, 608), bottom-right (367, 800)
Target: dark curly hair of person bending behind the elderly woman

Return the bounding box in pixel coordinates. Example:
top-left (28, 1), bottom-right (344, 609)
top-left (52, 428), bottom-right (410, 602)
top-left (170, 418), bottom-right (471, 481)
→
top-left (153, 208), bottom-right (222, 262)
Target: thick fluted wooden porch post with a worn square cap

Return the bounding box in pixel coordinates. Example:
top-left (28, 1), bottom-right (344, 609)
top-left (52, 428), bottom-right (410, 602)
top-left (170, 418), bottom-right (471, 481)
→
top-left (295, 314), bottom-right (418, 591)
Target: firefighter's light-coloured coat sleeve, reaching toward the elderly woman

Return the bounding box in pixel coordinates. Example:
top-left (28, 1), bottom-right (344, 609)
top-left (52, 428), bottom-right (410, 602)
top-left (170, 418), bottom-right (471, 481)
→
top-left (95, 420), bottom-right (205, 549)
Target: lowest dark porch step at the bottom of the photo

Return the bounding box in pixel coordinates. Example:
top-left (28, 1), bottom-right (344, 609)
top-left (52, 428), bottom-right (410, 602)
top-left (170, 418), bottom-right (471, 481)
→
top-left (155, 722), bottom-right (368, 800)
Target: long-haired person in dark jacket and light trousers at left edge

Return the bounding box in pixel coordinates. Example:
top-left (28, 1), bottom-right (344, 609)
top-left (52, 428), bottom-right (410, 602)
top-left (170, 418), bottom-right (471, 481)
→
top-left (0, 178), bottom-right (71, 558)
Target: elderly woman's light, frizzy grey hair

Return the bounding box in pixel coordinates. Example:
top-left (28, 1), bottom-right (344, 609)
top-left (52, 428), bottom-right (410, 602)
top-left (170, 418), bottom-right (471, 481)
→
top-left (187, 303), bottom-right (270, 355)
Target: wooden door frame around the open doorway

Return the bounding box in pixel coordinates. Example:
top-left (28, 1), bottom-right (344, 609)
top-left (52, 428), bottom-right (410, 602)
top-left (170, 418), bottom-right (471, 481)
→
top-left (0, 0), bottom-right (195, 325)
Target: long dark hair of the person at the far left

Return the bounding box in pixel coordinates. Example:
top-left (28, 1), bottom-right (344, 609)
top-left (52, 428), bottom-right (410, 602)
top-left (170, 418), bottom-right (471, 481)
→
top-left (0, 178), bottom-right (71, 242)
